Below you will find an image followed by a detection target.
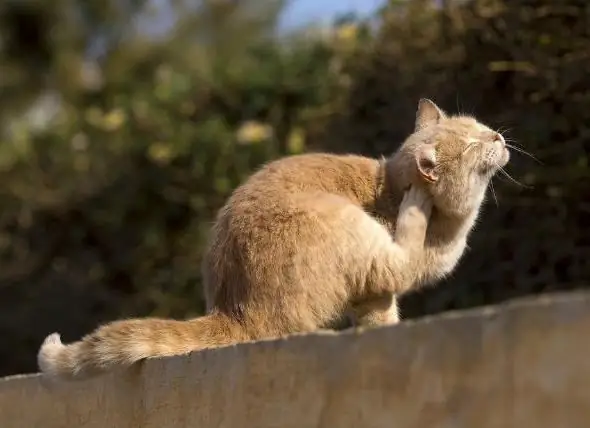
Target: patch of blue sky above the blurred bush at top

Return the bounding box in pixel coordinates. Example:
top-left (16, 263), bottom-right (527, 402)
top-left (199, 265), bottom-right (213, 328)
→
top-left (281, 0), bottom-right (385, 28)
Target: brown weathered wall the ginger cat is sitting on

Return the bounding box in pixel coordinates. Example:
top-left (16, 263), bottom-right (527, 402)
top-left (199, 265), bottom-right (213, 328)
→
top-left (0, 293), bottom-right (590, 428)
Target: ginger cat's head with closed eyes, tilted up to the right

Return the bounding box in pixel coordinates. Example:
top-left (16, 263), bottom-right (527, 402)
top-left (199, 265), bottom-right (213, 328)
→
top-left (402, 99), bottom-right (510, 215)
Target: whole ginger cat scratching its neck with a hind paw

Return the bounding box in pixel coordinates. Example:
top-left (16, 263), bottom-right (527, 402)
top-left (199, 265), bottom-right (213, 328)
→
top-left (38, 100), bottom-right (509, 379)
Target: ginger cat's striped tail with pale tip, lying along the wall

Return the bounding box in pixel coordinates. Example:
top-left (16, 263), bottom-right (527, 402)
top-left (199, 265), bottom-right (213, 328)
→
top-left (37, 313), bottom-right (247, 380)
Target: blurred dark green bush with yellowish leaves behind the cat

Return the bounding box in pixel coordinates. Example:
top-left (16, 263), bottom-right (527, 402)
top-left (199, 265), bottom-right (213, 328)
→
top-left (0, 0), bottom-right (590, 374)
